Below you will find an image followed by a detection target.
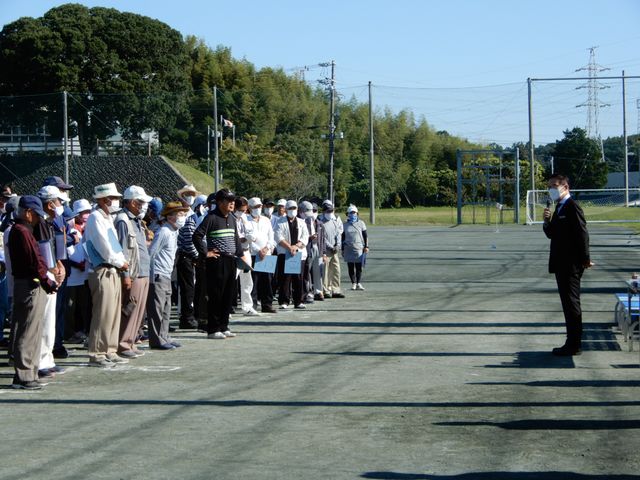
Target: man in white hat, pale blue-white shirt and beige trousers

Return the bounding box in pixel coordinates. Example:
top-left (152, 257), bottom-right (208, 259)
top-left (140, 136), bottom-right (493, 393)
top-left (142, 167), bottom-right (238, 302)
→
top-left (83, 183), bottom-right (129, 368)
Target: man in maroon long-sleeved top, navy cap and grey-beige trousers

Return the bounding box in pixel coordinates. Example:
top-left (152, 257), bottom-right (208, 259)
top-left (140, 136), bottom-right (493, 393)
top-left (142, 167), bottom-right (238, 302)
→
top-left (8, 195), bottom-right (62, 390)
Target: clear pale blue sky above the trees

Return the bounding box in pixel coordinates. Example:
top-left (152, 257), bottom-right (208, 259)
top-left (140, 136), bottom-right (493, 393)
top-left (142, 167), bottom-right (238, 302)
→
top-left (0, 0), bottom-right (640, 146)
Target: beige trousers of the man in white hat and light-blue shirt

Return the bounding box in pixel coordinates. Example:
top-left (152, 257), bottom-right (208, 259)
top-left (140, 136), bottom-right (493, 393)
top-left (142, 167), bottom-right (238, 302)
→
top-left (89, 268), bottom-right (122, 360)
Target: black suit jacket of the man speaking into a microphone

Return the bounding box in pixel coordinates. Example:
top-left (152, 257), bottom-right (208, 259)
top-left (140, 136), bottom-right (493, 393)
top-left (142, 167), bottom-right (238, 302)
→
top-left (543, 197), bottom-right (590, 273)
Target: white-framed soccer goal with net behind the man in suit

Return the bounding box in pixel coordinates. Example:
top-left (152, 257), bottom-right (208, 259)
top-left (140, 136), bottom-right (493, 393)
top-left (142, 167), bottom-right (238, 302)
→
top-left (527, 188), bottom-right (640, 225)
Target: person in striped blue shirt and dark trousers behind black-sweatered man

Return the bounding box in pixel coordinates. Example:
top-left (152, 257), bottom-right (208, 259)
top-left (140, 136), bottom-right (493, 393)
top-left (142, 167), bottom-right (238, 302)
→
top-left (176, 195), bottom-right (207, 329)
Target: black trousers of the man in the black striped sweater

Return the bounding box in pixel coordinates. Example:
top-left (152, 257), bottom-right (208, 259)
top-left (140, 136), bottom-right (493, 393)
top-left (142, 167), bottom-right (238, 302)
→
top-left (207, 256), bottom-right (236, 333)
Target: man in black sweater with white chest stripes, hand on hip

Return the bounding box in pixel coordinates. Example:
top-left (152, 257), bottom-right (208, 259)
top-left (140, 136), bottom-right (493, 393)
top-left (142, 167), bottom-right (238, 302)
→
top-left (193, 189), bottom-right (243, 340)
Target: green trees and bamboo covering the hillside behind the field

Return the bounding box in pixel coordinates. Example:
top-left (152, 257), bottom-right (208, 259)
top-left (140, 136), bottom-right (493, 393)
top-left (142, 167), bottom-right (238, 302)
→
top-left (0, 4), bottom-right (640, 206)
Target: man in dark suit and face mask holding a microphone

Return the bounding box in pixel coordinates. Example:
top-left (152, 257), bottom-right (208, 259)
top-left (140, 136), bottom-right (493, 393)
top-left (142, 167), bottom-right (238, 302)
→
top-left (543, 175), bottom-right (593, 356)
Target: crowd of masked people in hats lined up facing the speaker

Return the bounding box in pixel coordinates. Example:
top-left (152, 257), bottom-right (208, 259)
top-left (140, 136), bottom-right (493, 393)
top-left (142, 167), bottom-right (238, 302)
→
top-left (0, 177), bottom-right (368, 389)
